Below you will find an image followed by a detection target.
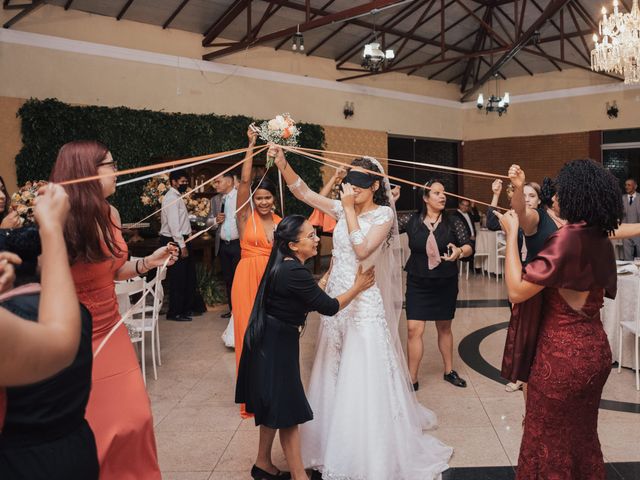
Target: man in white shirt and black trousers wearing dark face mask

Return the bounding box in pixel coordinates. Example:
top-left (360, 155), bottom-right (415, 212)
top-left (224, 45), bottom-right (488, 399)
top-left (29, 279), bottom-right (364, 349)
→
top-left (160, 170), bottom-right (196, 322)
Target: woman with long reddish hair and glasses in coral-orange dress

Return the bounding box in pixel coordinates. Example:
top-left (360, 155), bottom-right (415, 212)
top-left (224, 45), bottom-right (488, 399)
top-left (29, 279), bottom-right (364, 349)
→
top-left (50, 141), bottom-right (177, 480)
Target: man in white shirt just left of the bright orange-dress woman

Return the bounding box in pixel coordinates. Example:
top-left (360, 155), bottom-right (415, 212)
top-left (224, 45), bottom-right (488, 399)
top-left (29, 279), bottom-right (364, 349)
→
top-left (213, 172), bottom-right (240, 318)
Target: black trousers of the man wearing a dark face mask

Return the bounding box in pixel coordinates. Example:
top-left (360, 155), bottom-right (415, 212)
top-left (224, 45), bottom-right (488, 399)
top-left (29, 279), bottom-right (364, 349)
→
top-left (160, 237), bottom-right (196, 317)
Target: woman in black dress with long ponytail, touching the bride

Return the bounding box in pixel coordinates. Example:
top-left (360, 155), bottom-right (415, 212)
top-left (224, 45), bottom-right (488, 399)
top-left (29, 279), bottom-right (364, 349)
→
top-left (236, 215), bottom-right (374, 480)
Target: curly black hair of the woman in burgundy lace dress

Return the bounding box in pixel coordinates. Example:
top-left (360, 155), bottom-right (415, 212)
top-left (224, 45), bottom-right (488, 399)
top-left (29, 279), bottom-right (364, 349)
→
top-left (556, 160), bottom-right (623, 233)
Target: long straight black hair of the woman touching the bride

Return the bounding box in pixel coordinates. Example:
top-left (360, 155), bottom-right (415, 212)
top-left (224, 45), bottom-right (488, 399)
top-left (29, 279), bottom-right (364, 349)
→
top-left (244, 215), bottom-right (307, 349)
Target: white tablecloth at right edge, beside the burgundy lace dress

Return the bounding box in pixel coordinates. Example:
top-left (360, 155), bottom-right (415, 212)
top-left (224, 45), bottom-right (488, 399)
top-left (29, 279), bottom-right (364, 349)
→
top-left (601, 275), bottom-right (640, 367)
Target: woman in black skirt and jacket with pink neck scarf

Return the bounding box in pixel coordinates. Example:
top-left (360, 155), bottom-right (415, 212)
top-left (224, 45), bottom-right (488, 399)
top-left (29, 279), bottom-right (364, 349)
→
top-left (405, 179), bottom-right (473, 390)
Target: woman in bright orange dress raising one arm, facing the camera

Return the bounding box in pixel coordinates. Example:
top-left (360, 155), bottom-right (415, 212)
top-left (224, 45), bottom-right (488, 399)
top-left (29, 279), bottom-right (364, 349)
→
top-left (231, 128), bottom-right (281, 412)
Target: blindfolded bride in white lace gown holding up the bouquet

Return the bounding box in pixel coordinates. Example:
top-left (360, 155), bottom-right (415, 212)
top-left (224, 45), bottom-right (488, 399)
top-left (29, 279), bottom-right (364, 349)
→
top-left (269, 146), bottom-right (453, 480)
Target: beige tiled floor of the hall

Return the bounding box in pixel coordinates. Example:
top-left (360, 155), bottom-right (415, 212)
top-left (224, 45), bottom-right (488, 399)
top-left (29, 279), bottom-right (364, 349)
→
top-left (147, 275), bottom-right (640, 480)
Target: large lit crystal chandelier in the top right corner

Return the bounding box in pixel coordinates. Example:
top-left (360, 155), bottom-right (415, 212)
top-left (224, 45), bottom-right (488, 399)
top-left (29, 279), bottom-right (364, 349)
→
top-left (591, 0), bottom-right (640, 84)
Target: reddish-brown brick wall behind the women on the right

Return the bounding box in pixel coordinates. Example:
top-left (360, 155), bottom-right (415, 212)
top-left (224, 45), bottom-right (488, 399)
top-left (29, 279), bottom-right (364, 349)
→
top-left (460, 132), bottom-right (599, 210)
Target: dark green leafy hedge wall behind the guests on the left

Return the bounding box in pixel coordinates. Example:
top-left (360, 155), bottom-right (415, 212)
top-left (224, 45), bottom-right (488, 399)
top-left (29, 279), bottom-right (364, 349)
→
top-left (16, 99), bottom-right (325, 223)
